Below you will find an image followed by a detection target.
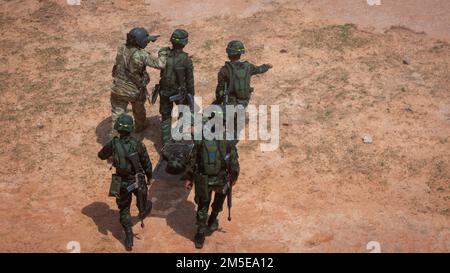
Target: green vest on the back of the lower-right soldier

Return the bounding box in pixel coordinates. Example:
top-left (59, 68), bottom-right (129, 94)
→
top-left (199, 140), bottom-right (230, 176)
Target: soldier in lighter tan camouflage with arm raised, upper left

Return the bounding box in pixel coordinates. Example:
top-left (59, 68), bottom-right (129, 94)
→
top-left (111, 28), bottom-right (168, 133)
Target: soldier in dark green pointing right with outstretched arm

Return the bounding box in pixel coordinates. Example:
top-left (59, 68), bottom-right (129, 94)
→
top-left (216, 40), bottom-right (272, 108)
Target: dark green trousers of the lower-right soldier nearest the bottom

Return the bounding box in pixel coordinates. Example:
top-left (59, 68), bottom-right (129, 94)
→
top-left (195, 176), bottom-right (226, 232)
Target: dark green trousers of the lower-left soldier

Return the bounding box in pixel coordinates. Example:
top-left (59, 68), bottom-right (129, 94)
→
top-left (116, 180), bottom-right (148, 229)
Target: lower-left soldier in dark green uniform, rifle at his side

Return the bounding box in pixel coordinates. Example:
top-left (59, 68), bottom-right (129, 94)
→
top-left (98, 114), bottom-right (152, 250)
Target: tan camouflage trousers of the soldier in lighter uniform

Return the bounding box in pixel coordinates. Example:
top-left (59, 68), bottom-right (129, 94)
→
top-left (111, 93), bottom-right (146, 131)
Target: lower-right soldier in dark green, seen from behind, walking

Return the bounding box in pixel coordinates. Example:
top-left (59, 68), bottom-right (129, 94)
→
top-left (186, 109), bottom-right (239, 248)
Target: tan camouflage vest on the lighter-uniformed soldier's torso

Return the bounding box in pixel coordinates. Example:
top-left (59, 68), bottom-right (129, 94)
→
top-left (112, 45), bottom-right (150, 89)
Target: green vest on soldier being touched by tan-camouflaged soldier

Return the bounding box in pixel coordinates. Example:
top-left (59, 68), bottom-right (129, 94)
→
top-left (160, 50), bottom-right (188, 95)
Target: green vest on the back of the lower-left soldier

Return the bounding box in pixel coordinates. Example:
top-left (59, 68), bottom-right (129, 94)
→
top-left (112, 136), bottom-right (138, 175)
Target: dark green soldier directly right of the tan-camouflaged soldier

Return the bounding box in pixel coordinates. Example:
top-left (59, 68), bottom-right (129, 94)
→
top-left (155, 29), bottom-right (195, 145)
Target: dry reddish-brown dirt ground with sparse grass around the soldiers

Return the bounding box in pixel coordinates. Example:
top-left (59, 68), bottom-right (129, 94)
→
top-left (0, 0), bottom-right (450, 252)
